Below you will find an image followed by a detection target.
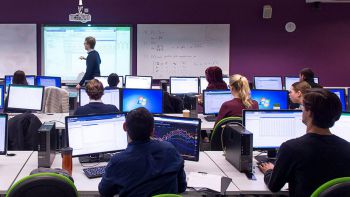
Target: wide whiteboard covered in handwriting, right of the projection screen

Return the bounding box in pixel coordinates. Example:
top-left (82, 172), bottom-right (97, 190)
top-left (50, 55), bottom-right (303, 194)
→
top-left (137, 24), bottom-right (230, 79)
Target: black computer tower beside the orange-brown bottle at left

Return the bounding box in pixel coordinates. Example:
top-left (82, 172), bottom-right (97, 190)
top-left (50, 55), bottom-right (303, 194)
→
top-left (37, 122), bottom-right (57, 168)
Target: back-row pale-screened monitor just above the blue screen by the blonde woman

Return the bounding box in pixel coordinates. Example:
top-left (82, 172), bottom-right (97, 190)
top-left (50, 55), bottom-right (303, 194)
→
top-left (254, 77), bottom-right (283, 90)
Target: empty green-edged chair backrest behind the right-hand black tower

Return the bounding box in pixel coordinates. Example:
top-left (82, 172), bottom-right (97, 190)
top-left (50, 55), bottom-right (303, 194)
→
top-left (210, 117), bottom-right (242, 151)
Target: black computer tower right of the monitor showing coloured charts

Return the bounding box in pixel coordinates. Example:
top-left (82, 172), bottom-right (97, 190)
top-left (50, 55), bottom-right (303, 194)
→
top-left (224, 123), bottom-right (253, 173)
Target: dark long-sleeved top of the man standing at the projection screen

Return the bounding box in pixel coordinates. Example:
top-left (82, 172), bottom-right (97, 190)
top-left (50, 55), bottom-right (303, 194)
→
top-left (79, 50), bottom-right (101, 86)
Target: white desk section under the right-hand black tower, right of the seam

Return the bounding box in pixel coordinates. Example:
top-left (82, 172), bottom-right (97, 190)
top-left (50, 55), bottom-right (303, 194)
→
top-left (205, 151), bottom-right (288, 194)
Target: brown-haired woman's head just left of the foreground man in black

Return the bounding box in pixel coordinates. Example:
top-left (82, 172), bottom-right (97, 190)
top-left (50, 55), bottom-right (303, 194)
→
top-left (289, 81), bottom-right (311, 109)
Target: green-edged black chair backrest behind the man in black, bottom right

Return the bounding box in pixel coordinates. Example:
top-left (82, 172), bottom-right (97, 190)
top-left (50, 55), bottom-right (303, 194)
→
top-left (311, 177), bottom-right (350, 197)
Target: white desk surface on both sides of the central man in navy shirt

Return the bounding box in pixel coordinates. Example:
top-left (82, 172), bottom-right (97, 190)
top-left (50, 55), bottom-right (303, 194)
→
top-left (16, 152), bottom-right (239, 196)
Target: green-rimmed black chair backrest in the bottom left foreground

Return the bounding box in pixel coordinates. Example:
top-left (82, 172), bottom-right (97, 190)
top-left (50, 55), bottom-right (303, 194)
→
top-left (7, 173), bottom-right (78, 197)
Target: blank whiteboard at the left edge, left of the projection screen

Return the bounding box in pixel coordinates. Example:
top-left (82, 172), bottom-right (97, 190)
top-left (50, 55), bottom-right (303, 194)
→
top-left (0, 24), bottom-right (37, 78)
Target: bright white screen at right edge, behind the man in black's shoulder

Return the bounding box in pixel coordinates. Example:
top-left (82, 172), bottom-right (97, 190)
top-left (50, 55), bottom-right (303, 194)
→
top-left (330, 112), bottom-right (350, 142)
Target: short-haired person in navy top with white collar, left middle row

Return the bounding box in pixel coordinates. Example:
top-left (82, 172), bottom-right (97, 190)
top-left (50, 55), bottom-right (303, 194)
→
top-left (74, 79), bottom-right (119, 115)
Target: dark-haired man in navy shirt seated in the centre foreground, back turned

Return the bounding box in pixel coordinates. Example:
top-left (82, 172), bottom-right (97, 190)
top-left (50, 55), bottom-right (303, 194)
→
top-left (98, 108), bottom-right (187, 197)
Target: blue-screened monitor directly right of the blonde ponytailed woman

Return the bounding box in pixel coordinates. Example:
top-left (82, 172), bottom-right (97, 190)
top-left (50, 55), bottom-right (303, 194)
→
top-left (251, 90), bottom-right (288, 109)
